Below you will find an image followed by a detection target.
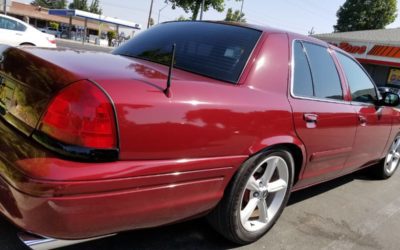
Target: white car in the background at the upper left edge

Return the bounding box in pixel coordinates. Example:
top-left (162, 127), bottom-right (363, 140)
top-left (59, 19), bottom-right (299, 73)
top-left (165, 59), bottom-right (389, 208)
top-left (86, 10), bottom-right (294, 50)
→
top-left (0, 14), bottom-right (57, 48)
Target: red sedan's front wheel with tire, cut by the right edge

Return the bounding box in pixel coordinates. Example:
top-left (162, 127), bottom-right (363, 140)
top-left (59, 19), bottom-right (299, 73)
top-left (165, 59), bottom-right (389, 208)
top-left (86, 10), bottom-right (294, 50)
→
top-left (372, 135), bottom-right (400, 180)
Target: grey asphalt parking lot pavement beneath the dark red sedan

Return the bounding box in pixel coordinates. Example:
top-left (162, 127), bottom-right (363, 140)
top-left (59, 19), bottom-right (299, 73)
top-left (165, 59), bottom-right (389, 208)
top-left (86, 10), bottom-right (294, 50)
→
top-left (0, 168), bottom-right (400, 250)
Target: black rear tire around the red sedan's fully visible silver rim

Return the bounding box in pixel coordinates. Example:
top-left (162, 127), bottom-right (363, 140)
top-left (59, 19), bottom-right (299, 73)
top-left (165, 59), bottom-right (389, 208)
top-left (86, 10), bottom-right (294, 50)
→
top-left (207, 149), bottom-right (294, 245)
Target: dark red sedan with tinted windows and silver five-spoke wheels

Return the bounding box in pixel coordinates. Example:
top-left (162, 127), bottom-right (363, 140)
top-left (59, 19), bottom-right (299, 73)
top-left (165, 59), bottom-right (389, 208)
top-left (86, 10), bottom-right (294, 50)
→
top-left (0, 22), bottom-right (400, 247)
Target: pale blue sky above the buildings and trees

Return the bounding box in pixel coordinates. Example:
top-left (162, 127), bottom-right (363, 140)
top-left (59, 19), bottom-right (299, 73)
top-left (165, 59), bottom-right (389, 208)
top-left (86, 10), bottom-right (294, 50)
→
top-left (18, 0), bottom-right (400, 34)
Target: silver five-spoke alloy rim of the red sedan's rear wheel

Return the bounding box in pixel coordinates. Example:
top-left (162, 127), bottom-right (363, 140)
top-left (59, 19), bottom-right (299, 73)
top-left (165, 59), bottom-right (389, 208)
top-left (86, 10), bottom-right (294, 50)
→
top-left (240, 156), bottom-right (289, 232)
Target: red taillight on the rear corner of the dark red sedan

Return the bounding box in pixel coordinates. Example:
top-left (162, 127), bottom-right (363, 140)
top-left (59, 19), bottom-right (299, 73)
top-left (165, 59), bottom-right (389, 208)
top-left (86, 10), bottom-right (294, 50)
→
top-left (38, 81), bottom-right (117, 149)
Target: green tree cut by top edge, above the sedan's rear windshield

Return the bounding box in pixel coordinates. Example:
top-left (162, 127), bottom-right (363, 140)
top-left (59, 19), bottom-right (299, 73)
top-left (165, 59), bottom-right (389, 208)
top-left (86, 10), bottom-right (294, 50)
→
top-left (167, 0), bottom-right (225, 20)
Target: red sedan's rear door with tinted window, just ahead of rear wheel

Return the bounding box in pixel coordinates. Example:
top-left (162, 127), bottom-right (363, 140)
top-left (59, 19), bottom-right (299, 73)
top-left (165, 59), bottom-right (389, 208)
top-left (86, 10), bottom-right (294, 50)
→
top-left (289, 41), bottom-right (357, 185)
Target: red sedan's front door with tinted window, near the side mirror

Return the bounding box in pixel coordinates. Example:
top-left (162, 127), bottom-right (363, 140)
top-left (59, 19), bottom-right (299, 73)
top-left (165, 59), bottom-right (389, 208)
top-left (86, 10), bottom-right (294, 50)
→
top-left (336, 52), bottom-right (393, 171)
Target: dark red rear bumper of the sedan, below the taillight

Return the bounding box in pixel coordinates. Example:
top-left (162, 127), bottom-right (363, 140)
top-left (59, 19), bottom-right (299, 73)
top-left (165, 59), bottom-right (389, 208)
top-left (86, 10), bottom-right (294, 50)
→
top-left (0, 122), bottom-right (245, 239)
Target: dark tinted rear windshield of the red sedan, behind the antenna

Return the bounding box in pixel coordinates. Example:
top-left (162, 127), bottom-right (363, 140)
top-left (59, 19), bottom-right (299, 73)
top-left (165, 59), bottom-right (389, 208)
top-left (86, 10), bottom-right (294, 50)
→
top-left (113, 22), bottom-right (262, 83)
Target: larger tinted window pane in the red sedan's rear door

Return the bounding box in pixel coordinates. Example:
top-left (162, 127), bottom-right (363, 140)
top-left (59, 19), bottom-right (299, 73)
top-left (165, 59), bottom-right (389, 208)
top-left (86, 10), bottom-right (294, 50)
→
top-left (303, 42), bottom-right (343, 100)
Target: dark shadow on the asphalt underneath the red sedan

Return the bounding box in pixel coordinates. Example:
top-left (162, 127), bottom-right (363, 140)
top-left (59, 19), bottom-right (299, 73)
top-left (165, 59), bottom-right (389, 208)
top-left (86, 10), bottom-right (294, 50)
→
top-left (0, 171), bottom-right (382, 250)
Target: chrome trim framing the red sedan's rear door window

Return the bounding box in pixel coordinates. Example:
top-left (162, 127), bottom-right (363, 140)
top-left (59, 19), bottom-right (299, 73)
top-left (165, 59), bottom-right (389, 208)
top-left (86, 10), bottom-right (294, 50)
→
top-left (290, 39), bottom-right (351, 104)
